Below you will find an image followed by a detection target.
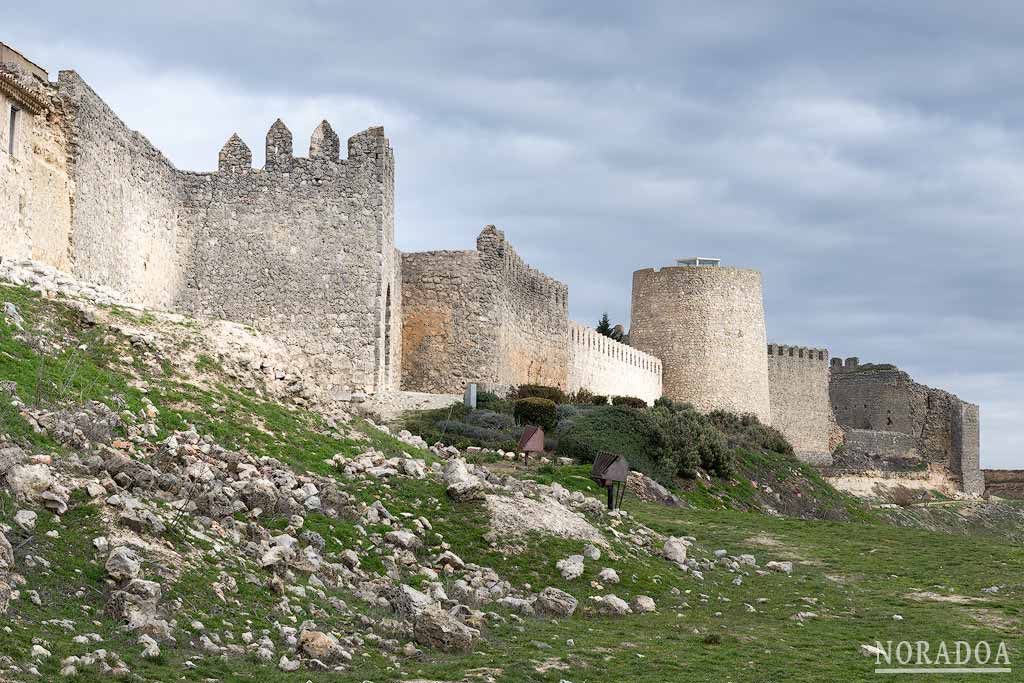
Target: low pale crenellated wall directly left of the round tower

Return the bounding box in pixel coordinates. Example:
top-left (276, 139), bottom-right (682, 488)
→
top-left (568, 321), bottom-right (662, 403)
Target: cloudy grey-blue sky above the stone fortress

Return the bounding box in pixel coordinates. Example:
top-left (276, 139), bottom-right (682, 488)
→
top-left (8, 0), bottom-right (1024, 467)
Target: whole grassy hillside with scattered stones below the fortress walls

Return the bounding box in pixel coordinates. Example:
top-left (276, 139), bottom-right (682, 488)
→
top-left (0, 280), bottom-right (1024, 683)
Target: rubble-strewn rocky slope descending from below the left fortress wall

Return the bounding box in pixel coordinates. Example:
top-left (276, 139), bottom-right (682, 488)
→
top-left (0, 259), bottom-right (792, 680)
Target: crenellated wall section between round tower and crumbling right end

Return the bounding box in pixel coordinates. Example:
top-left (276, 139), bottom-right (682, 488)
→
top-left (768, 344), bottom-right (836, 465)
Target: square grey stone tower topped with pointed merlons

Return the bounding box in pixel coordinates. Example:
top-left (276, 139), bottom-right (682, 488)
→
top-left (175, 120), bottom-right (401, 399)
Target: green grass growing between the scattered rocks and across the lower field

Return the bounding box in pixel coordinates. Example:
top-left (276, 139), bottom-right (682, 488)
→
top-left (0, 280), bottom-right (1024, 683)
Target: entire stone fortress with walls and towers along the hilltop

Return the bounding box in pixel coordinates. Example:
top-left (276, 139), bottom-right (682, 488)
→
top-left (0, 44), bottom-right (991, 493)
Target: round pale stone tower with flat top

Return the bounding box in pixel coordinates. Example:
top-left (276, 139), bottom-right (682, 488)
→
top-left (630, 258), bottom-right (771, 424)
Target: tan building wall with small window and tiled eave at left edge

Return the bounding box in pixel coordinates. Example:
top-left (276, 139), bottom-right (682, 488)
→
top-left (0, 65), bottom-right (72, 270)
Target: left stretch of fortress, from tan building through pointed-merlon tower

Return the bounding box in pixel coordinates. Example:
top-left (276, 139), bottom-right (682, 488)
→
top-left (0, 52), bottom-right (401, 399)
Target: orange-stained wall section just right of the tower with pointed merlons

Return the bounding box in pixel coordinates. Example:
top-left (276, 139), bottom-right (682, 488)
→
top-left (401, 225), bottom-right (568, 393)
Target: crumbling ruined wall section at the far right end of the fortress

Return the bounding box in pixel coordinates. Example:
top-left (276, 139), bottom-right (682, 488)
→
top-left (828, 357), bottom-right (984, 495)
